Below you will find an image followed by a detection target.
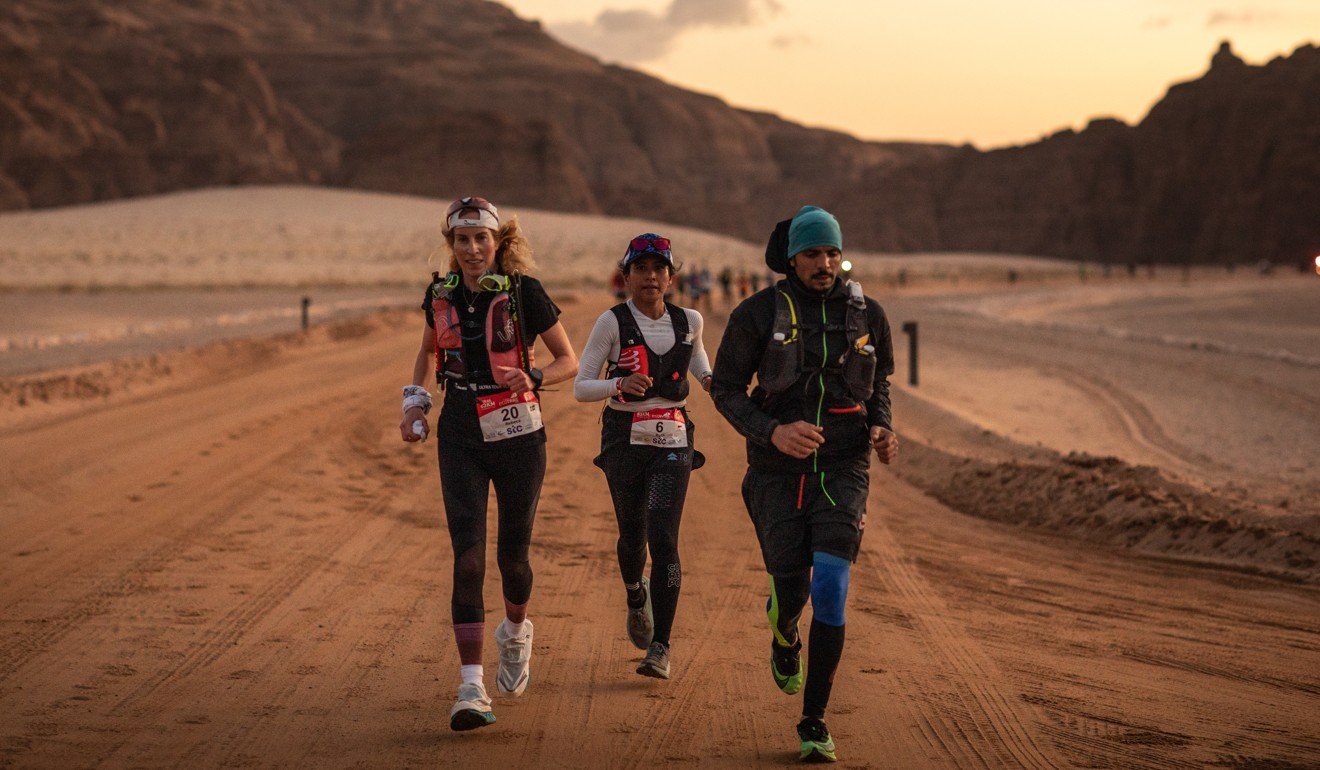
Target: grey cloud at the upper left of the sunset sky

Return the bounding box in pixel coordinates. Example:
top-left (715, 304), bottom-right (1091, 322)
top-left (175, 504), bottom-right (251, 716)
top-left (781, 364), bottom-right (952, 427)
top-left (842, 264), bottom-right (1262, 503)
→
top-left (550, 0), bottom-right (783, 62)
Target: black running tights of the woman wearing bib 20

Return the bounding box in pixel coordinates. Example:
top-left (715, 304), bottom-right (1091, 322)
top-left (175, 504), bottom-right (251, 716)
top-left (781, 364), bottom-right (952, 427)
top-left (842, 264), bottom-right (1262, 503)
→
top-left (437, 442), bottom-right (545, 623)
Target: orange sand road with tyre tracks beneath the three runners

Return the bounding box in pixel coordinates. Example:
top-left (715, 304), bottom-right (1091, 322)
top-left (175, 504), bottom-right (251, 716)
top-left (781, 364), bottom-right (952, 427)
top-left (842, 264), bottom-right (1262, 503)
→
top-left (0, 291), bottom-right (1320, 767)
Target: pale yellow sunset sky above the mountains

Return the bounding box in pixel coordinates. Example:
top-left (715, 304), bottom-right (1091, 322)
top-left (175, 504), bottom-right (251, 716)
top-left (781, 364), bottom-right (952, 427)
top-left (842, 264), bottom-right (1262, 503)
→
top-left (503, 0), bottom-right (1320, 148)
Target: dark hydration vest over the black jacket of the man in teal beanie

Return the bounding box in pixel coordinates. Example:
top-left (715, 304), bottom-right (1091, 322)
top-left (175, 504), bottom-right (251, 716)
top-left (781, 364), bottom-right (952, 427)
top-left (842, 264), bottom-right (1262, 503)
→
top-left (756, 280), bottom-right (875, 402)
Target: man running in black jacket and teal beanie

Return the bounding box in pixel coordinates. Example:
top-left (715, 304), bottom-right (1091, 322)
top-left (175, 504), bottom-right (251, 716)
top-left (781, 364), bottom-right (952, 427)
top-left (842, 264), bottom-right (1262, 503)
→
top-left (711, 206), bottom-right (898, 762)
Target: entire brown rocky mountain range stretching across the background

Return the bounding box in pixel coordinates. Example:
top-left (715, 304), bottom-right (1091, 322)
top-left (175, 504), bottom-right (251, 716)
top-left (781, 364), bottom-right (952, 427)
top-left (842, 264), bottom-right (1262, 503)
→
top-left (0, 0), bottom-right (1320, 262)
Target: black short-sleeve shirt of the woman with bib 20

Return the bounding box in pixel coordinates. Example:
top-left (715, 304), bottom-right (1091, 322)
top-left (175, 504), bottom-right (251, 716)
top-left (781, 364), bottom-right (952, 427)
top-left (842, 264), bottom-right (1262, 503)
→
top-left (421, 276), bottom-right (560, 448)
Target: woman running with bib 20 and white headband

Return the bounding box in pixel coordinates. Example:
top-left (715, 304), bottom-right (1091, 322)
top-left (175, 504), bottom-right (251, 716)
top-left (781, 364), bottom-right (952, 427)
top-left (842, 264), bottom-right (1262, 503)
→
top-left (399, 198), bottom-right (577, 730)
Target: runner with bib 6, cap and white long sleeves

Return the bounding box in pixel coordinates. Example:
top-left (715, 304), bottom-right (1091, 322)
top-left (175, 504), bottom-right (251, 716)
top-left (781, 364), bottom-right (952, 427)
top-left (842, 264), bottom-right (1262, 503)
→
top-left (573, 232), bottom-right (710, 679)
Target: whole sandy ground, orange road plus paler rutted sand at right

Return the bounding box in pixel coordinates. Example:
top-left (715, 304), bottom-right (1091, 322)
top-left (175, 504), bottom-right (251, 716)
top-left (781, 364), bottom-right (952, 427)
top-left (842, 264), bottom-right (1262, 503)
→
top-left (0, 190), bottom-right (1320, 767)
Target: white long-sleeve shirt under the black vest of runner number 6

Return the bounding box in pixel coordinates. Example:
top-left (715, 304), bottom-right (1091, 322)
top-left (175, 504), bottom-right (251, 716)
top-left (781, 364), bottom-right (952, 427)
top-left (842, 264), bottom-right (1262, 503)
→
top-left (573, 300), bottom-right (710, 412)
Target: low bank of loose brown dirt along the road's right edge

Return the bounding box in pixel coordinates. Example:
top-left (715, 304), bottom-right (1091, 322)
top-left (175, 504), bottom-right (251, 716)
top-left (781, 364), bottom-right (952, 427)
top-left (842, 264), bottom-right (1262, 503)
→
top-left (895, 442), bottom-right (1320, 582)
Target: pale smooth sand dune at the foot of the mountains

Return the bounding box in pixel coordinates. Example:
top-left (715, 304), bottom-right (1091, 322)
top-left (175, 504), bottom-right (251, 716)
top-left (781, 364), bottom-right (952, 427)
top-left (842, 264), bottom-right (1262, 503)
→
top-left (0, 186), bottom-right (1076, 289)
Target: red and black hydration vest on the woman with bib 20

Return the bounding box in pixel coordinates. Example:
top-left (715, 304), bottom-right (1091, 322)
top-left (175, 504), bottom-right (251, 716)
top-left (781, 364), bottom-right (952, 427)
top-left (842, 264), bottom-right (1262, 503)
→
top-left (430, 272), bottom-right (533, 392)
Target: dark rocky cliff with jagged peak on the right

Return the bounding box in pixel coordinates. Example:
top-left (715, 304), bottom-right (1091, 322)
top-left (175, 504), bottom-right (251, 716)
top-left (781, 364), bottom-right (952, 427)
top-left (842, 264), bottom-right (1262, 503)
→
top-left (841, 44), bottom-right (1320, 269)
